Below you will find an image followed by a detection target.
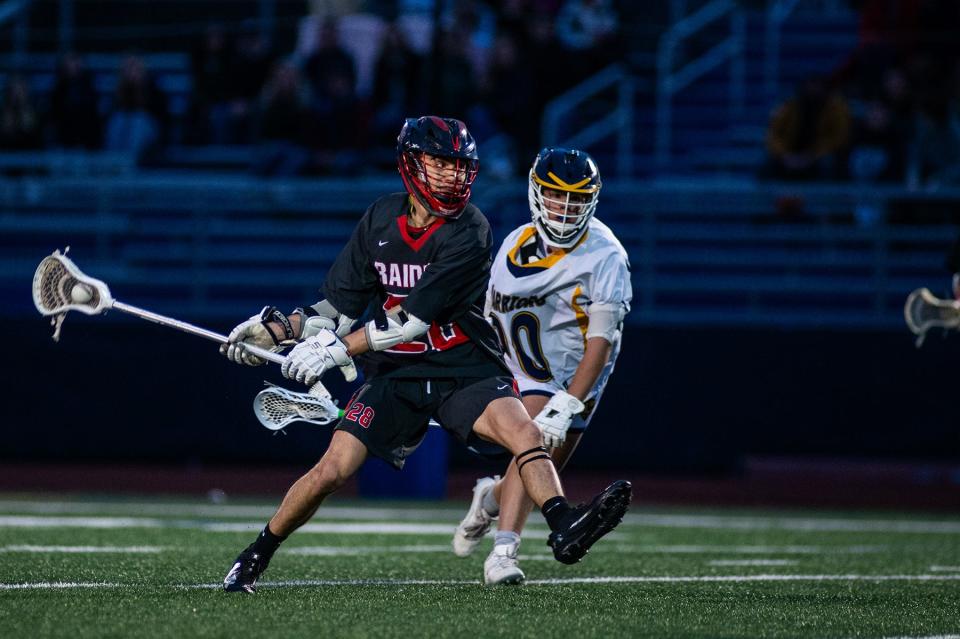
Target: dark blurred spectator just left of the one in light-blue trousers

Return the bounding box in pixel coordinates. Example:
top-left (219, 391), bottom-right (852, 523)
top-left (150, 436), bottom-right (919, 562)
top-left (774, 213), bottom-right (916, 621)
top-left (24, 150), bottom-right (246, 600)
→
top-left (50, 53), bottom-right (103, 149)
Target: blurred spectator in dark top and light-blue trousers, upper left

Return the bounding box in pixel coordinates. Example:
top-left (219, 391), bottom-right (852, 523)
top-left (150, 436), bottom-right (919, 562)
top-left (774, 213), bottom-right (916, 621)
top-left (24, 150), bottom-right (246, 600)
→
top-left (105, 55), bottom-right (168, 158)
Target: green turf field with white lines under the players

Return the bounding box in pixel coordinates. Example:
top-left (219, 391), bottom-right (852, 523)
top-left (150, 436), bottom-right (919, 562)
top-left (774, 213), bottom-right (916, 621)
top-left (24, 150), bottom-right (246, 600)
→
top-left (0, 496), bottom-right (960, 639)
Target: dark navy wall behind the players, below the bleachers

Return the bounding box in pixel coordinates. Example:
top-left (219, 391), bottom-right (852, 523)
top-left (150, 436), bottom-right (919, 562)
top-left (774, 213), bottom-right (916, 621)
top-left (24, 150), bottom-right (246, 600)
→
top-left (9, 316), bottom-right (960, 473)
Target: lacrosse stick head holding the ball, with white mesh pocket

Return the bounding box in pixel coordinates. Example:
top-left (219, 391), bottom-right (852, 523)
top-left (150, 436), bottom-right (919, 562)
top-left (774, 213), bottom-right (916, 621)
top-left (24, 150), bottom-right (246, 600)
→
top-left (33, 246), bottom-right (113, 340)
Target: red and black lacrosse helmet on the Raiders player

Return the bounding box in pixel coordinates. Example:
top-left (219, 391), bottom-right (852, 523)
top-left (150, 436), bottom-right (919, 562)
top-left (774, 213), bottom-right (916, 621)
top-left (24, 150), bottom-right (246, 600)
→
top-left (397, 115), bottom-right (480, 218)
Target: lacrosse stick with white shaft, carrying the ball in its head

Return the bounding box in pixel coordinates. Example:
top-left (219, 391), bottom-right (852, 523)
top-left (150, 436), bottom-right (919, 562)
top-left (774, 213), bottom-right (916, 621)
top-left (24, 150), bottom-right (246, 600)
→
top-left (33, 246), bottom-right (286, 364)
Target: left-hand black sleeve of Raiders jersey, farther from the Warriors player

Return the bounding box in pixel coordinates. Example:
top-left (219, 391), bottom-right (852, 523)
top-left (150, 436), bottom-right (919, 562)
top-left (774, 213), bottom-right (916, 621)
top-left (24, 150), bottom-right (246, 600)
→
top-left (322, 206), bottom-right (379, 318)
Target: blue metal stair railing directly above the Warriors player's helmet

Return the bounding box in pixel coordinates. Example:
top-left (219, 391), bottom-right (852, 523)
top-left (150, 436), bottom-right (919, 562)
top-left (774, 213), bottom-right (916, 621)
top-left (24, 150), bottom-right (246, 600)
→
top-left (541, 64), bottom-right (634, 177)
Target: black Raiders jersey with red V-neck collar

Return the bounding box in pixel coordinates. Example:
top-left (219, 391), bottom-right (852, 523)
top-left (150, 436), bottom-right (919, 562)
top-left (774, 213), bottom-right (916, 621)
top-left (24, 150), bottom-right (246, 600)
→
top-left (323, 193), bottom-right (509, 377)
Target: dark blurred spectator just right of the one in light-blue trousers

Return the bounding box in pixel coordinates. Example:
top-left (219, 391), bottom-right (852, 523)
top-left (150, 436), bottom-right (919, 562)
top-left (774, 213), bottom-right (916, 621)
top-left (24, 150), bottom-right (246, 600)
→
top-left (188, 24), bottom-right (233, 144)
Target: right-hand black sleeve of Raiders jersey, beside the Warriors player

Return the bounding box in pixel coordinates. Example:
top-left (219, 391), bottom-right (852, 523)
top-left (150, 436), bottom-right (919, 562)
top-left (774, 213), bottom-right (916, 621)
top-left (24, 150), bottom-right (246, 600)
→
top-left (403, 224), bottom-right (493, 324)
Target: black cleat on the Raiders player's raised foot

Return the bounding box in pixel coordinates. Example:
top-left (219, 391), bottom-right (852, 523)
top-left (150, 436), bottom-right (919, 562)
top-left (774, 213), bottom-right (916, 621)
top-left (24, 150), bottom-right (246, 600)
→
top-left (547, 479), bottom-right (632, 564)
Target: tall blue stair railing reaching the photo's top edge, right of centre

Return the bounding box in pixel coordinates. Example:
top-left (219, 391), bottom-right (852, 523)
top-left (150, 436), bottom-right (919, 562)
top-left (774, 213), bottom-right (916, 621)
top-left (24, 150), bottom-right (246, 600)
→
top-left (655, 0), bottom-right (746, 166)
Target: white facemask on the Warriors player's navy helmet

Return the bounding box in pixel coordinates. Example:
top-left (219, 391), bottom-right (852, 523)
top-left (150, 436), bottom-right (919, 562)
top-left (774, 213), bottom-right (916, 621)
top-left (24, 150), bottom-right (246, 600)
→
top-left (527, 170), bottom-right (600, 248)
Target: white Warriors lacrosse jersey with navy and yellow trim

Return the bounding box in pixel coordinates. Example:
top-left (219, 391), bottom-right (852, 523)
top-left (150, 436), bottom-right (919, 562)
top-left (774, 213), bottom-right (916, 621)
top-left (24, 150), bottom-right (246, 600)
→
top-left (485, 218), bottom-right (633, 424)
